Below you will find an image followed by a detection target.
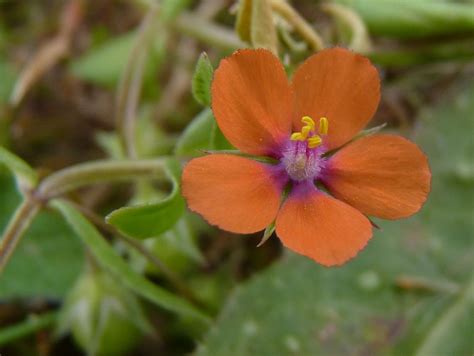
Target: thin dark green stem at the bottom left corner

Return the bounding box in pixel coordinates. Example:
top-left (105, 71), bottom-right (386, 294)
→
top-left (0, 312), bottom-right (58, 346)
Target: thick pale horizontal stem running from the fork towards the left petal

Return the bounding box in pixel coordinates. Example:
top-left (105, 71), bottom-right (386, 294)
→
top-left (37, 157), bottom-right (166, 199)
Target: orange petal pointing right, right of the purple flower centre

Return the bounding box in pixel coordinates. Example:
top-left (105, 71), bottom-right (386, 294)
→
top-left (323, 135), bottom-right (431, 219)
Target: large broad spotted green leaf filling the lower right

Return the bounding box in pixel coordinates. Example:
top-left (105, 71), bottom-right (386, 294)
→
top-left (197, 83), bottom-right (474, 356)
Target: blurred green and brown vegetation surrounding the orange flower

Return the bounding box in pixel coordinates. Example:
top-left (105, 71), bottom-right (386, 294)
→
top-left (0, 0), bottom-right (474, 356)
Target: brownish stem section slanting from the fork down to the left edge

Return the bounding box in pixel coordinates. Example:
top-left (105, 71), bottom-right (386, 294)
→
top-left (0, 197), bottom-right (41, 273)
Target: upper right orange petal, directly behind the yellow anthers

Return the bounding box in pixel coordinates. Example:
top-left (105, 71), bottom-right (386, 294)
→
top-left (293, 48), bottom-right (380, 149)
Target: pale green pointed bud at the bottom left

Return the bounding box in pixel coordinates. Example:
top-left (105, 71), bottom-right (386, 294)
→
top-left (59, 268), bottom-right (152, 356)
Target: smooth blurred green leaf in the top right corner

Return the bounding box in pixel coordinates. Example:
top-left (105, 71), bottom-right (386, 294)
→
top-left (335, 0), bottom-right (474, 38)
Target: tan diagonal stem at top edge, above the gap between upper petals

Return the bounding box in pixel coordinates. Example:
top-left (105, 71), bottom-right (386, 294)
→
top-left (271, 0), bottom-right (324, 51)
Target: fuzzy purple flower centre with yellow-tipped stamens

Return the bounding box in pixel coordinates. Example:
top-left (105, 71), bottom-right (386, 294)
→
top-left (281, 116), bottom-right (329, 181)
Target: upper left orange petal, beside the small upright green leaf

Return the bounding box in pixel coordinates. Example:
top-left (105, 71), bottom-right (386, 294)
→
top-left (212, 49), bottom-right (293, 155)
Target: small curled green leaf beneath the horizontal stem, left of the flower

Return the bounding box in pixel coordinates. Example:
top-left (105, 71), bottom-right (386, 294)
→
top-left (106, 159), bottom-right (185, 239)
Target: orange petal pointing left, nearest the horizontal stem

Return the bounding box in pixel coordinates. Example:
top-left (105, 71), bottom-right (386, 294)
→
top-left (182, 154), bottom-right (282, 233)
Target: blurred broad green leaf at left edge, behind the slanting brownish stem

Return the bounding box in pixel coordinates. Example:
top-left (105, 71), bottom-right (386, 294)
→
top-left (0, 171), bottom-right (83, 300)
